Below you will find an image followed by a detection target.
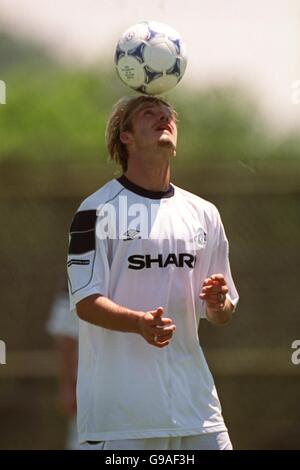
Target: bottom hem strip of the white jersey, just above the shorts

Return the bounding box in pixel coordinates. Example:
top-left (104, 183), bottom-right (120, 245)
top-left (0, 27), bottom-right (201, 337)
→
top-left (79, 423), bottom-right (228, 444)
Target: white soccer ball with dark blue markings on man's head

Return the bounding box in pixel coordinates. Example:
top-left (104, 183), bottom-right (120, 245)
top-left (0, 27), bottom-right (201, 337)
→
top-left (115, 21), bottom-right (187, 95)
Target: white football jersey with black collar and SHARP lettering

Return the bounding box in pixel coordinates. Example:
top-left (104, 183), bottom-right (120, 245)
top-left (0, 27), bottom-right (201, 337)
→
top-left (68, 176), bottom-right (238, 442)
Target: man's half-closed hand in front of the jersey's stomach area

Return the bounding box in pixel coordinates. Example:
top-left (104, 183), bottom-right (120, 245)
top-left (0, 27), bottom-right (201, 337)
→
top-left (139, 307), bottom-right (176, 348)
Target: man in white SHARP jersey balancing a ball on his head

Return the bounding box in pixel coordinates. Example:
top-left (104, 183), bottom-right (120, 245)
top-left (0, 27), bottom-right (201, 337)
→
top-left (68, 96), bottom-right (238, 450)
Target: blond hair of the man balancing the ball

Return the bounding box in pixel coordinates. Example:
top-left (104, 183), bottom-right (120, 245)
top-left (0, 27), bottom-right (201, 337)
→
top-left (105, 95), bottom-right (177, 172)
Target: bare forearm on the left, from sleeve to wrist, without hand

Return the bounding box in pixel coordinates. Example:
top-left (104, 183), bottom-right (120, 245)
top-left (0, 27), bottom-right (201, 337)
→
top-left (76, 295), bottom-right (145, 333)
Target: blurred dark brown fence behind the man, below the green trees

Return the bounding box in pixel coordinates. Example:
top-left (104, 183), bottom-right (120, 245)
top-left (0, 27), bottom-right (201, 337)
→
top-left (0, 160), bottom-right (300, 449)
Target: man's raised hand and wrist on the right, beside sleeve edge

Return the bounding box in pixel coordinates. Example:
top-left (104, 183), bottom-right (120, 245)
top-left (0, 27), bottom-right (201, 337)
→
top-left (199, 274), bottom-right (233, 325)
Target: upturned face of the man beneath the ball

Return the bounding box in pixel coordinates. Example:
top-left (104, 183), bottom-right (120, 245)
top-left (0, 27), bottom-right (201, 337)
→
top-left (122, 103), bottom-right (177, 154)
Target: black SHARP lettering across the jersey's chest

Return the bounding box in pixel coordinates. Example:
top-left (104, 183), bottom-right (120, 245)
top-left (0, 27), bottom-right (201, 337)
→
top-left (128, 253), bottom-right (196, 269)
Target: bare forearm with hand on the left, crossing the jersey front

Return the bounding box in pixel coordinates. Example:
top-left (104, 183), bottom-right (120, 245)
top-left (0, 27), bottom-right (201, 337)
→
top-left (76, 294), bottom-right (176, 348)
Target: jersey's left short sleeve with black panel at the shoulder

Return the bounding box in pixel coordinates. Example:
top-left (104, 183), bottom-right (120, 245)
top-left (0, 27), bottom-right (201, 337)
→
top-left (67, 210), bottom-right (110, 310)
